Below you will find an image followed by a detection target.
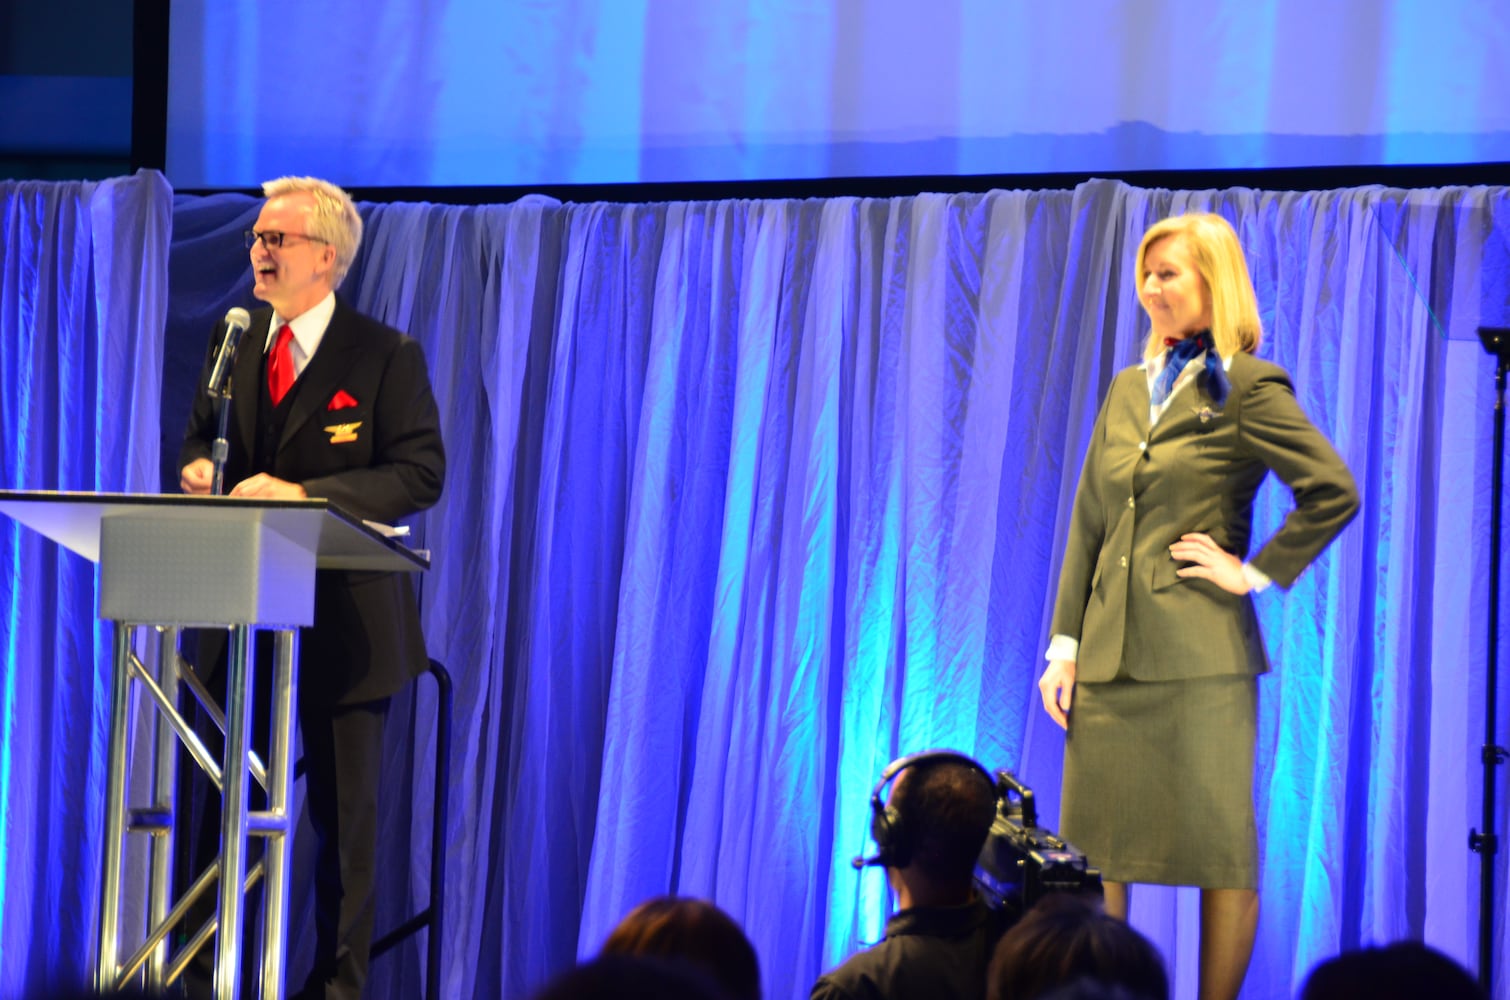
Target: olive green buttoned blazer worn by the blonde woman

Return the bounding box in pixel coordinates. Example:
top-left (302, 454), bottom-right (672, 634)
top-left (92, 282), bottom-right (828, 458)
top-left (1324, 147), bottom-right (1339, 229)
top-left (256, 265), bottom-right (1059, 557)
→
top-left (1052, 353), bottom-right (1357, 681)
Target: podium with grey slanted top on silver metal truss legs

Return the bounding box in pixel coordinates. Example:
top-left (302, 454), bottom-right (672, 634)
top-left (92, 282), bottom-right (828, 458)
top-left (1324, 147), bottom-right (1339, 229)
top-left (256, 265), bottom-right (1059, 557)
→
top-left (0, 491), bottom-right (429, 998)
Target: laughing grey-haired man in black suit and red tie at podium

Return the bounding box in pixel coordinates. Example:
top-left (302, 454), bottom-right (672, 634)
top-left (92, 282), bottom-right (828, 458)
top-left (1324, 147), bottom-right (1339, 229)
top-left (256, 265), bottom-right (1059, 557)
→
top-left (178, 177), bottom-right (445, 1000)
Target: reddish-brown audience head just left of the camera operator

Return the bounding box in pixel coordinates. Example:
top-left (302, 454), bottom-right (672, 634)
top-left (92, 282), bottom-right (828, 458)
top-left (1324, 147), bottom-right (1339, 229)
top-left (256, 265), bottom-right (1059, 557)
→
top-left (602, 896), bottom-right (760, 1000)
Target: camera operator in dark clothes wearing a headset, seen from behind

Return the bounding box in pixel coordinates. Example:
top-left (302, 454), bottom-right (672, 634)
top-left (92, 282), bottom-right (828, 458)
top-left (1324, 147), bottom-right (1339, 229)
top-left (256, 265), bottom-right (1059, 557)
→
top-left (811, 751), bottom-right (1004, 1000)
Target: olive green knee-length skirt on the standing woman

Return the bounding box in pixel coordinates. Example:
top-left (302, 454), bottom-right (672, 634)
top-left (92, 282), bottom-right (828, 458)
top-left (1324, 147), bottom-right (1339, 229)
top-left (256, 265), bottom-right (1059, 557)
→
top-left (1059, 675), bottom-right (1258, 888)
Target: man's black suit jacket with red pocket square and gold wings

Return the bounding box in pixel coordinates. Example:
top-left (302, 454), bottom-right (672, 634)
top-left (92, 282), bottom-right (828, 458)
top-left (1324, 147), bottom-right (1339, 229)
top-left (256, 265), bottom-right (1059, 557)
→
top-left (178, 299), bottom-right (445, 704)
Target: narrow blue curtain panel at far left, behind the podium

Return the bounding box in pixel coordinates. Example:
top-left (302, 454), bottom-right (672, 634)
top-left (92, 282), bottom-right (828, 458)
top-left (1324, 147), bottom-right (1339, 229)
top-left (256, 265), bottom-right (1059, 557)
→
top-left (0, 172), bottom-right (172, 997)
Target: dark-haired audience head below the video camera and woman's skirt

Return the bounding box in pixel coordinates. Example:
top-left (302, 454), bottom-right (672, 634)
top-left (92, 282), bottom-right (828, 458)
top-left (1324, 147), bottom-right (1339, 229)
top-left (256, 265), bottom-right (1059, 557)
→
top-left (988, 894), bottom-right (1169, 1000)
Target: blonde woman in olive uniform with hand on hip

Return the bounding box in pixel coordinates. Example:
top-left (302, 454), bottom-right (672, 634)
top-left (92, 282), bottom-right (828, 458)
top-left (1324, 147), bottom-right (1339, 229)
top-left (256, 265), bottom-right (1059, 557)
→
top-left (1039, 215), bottom-right (1357, 1000)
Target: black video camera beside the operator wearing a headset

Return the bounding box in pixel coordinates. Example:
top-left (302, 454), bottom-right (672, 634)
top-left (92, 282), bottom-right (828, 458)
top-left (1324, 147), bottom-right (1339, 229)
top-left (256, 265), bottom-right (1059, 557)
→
top-left (975, 769), bottom-right (1101, 920)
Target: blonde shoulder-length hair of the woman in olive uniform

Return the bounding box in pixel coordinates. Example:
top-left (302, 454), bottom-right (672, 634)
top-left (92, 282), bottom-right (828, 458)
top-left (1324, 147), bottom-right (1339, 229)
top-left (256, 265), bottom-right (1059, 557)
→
top-left (1137, 211), bottom-right (1264, 358)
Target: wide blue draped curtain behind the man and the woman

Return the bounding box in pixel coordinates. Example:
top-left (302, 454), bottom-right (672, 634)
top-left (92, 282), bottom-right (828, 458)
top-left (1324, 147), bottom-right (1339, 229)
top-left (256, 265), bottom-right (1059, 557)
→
top-left (5, 181), bottom-right (1510, 998)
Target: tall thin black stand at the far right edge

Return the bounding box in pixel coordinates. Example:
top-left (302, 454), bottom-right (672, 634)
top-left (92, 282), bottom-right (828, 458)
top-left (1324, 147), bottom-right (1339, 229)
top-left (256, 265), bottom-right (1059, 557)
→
top-left (1468, 326), bottom-right (1510, 994)
